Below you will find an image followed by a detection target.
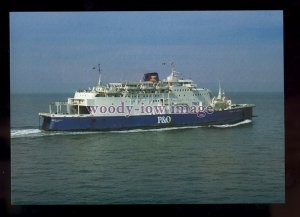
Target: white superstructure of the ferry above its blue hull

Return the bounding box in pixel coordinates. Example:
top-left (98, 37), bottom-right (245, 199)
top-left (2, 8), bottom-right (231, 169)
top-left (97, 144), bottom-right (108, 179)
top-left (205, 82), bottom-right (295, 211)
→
top-left (50, 64), bottom-right (231, 116)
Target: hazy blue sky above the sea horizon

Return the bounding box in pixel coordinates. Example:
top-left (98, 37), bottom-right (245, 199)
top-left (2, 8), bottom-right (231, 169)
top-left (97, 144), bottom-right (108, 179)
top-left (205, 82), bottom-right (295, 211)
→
top-left (10, 11), bottom-right (284, 93)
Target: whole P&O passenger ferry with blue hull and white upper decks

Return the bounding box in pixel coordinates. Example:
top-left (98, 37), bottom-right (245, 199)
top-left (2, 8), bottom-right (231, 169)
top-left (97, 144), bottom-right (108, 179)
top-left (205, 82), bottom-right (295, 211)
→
top-left (39, 63), bottom-right (255, 131)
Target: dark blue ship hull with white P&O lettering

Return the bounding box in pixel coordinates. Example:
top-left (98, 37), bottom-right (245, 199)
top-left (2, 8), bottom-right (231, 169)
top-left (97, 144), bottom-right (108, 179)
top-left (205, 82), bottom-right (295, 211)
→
top-left (41, 106), bottom-right (252, 131)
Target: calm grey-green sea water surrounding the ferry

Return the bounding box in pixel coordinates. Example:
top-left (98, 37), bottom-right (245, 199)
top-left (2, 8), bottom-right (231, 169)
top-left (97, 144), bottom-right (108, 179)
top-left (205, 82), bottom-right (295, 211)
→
top-left (11, 93), bottom-right (285, 205)
